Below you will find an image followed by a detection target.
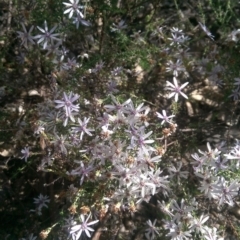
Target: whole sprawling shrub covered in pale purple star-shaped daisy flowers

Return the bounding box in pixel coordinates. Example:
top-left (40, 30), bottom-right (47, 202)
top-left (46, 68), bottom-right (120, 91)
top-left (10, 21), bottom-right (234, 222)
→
top-left (0, 0), bottom-right (240, 240)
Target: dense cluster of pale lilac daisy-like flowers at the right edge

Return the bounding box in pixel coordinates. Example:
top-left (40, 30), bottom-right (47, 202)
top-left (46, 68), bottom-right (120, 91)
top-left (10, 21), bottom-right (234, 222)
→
top-left (192, 142), bottom-right (240, 206)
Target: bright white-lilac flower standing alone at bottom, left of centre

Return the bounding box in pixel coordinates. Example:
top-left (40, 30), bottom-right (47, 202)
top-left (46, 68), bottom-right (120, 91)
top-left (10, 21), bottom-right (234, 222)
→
top-left (70, 214), bottom-right (99, 240)
